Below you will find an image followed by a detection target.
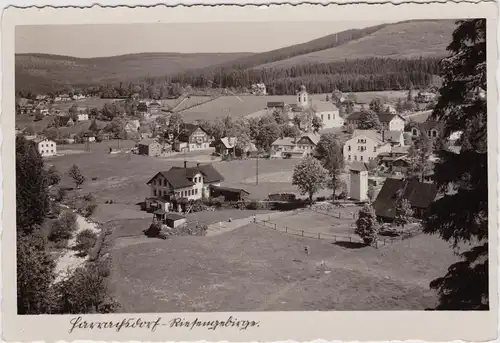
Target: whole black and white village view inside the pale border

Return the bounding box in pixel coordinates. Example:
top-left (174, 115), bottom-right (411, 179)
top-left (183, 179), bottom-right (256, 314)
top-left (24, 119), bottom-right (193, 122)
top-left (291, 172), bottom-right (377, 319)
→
top-left (3, 2), bottom-right (497, 338)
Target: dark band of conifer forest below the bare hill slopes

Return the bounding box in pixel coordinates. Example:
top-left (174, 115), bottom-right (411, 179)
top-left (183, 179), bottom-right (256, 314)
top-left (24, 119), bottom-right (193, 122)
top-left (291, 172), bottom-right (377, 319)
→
top-left (17, 58), bottom-right (440, 99)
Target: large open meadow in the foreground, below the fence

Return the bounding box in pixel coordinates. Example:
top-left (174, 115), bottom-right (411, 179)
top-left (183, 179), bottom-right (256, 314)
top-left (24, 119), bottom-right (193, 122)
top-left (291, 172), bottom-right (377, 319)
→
top-left (112, 225), bottom-right (456, 313)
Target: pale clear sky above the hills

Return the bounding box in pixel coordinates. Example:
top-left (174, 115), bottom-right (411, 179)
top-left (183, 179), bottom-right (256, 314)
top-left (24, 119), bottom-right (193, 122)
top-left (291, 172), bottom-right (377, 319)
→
top-left (16, 20), bottom-right (392, 57)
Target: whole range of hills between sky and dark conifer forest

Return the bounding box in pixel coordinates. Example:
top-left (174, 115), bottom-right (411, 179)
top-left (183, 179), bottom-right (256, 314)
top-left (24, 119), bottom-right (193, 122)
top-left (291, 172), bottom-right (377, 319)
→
top-left (16, 20), bottom-right (455, 91)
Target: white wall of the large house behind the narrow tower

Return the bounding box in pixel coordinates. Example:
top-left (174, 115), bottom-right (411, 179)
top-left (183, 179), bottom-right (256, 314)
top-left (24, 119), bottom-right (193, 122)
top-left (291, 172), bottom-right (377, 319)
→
top-left (343, 135), bottom-right (391, 162)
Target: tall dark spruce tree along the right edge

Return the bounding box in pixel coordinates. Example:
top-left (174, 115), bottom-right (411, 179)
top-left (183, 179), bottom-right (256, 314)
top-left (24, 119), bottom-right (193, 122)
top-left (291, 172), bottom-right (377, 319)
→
top-left (424, 19), bottom-right (488, 310)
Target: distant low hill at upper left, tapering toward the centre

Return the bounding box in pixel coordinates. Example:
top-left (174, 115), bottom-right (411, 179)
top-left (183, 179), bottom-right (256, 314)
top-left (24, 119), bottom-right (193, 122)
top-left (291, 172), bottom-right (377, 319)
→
top-left (16, 53), bottom-right (254, 90)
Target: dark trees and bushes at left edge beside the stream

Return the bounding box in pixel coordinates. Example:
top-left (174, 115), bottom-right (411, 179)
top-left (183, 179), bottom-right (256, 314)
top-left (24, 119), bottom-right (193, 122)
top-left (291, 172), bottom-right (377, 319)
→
top-left (16, 137), bottom-right (118, 314)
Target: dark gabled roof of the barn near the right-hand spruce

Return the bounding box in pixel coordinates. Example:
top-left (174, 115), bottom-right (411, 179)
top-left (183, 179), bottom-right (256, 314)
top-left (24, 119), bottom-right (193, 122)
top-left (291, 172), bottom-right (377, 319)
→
top-left (373, 178), bottom-right (437, 218)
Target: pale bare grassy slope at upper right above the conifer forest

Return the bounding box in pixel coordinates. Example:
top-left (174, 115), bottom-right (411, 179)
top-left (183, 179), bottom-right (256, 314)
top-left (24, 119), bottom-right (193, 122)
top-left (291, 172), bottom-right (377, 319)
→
top-left (259, 20), bottom-right (455, 68)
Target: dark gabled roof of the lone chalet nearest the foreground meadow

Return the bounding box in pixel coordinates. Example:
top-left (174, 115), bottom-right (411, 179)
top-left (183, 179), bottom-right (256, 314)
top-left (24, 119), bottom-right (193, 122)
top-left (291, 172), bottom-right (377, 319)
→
top-left (146, 164), bottom-right (224, 189)
